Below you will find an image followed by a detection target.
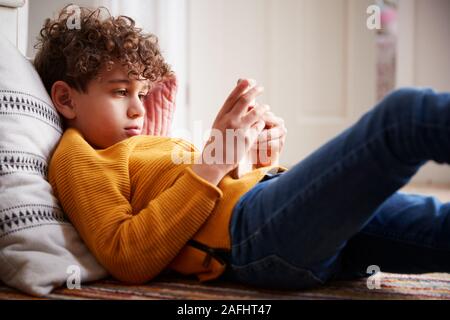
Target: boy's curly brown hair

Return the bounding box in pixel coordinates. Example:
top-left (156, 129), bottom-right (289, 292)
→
top-left (34, 5), bottom-right (172, 95)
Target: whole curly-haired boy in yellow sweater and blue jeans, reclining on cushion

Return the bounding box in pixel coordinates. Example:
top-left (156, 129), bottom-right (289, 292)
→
top-left (39, 5), bottom-right (450, 289)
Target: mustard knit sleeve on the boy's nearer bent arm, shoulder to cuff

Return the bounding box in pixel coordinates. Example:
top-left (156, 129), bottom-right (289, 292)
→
top-left (49, 139), bottom-right (222, 283)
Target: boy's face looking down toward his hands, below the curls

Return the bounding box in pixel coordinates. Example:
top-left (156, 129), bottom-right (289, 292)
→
top-left (70, 63), bottom-right (148, 149)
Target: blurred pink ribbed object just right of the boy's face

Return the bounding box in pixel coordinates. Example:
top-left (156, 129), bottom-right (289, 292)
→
top-left (142, 74), bottom-right (178, 136)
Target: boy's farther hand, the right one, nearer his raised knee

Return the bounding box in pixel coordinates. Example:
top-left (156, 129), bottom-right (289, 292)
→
top-left (250, 112), bottom-right (287, 168)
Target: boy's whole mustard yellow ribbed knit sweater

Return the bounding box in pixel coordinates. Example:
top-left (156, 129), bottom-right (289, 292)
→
top-left (49, 129), bottom-right (282, 283)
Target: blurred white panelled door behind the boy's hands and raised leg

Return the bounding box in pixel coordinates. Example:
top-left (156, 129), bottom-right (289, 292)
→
top-left (267, 0), bottom-right (376, 165)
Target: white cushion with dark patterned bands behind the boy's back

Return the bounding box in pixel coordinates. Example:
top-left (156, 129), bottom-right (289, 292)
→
top-left (0, 34), bottom-right (107, 295)
